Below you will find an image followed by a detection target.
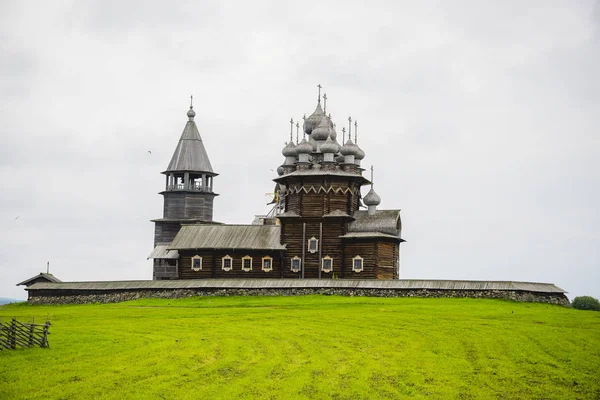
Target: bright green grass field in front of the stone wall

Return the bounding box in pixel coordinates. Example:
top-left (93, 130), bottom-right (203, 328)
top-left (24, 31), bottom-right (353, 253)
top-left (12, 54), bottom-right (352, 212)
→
top-left (0, 296), bottom-right (600, 399)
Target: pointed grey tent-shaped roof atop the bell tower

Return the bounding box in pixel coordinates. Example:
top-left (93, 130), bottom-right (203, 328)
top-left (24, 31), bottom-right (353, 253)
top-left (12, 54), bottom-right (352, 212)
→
top-left (163, 117), bottom-right (214, 174)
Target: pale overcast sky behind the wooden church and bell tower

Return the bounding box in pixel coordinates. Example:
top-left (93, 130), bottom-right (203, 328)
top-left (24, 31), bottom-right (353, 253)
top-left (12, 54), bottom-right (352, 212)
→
top-left (0, 0), bottom-right (600, 298)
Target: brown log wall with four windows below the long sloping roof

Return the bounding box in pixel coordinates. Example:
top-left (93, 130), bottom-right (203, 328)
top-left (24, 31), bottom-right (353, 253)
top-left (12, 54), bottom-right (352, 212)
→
top-left (179, 249), bottom-right (281, 279)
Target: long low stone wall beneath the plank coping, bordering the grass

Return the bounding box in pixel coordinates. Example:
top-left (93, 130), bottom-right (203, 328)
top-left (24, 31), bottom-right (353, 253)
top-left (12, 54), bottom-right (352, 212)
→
top-left (29, 288), bottom-right (570, 307)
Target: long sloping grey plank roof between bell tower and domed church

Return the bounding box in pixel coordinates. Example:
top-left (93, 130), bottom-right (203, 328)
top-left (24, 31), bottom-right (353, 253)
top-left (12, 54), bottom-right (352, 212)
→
top-left (168, 225), bottom-right (285, 250)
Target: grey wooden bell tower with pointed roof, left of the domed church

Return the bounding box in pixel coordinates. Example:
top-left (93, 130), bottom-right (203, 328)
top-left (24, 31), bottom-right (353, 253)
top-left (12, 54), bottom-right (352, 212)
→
top-left (150, 97), bottom-right (218, 280)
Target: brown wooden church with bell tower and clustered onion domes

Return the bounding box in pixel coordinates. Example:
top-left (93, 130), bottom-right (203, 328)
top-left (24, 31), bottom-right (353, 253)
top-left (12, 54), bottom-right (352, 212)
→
top-left (148, 86), bottom-right (404, 280)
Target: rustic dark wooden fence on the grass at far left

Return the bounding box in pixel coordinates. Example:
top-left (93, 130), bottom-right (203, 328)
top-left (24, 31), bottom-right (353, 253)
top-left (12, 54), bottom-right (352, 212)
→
top-left (0, 318), bottom-right (50, 350)
